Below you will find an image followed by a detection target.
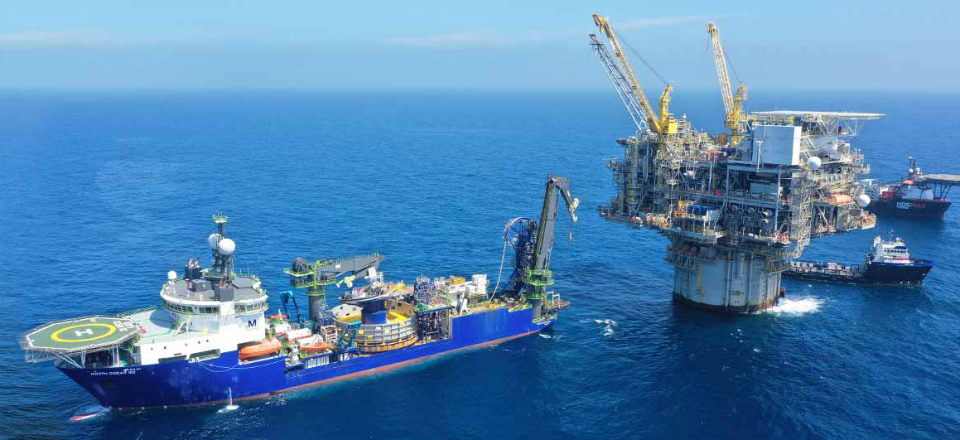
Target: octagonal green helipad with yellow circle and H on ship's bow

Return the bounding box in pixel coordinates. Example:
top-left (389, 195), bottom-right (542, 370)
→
top-left (20, 316), bottom-right (139, 367)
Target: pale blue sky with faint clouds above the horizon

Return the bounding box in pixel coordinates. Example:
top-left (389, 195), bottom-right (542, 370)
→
top-left (0, 0), bottom-right (960, 90)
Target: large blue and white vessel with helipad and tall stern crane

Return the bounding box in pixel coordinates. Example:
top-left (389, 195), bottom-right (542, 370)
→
top-left (20, 176), bottom-right (579, 408)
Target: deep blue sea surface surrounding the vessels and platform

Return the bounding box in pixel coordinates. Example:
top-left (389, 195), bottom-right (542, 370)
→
top-left (0, 90), bottom-right (960, 440)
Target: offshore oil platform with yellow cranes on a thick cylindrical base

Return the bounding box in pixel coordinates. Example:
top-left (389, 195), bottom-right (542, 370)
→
top-left (590, 14), bottom-right (883, 312)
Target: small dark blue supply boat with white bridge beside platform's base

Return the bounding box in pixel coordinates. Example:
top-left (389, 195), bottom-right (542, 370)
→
top-left (783, 235), bottom-right (933, 286)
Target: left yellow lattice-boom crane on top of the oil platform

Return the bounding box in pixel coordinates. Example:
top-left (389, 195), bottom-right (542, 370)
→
top-left (590, 14), bottom-right (677, 135)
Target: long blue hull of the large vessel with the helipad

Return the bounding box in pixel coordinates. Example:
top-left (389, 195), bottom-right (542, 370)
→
top-left (59, 308), bottom-right (554, 408)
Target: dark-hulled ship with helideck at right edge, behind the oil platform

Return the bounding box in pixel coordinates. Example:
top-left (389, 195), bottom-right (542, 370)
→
top-left (864, 157), bottom-right (960, 220)
